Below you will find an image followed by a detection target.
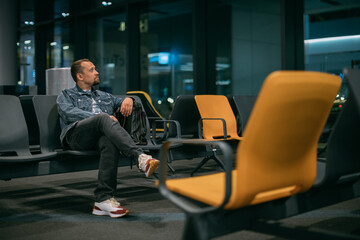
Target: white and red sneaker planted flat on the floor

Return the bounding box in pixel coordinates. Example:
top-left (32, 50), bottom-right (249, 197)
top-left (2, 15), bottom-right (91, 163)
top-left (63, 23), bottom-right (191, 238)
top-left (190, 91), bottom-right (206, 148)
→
top-left (92, 198), bottom-right (130, 218)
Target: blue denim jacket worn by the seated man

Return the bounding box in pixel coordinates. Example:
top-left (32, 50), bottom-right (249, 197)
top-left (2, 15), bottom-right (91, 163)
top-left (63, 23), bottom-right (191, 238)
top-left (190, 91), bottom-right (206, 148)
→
top-left (57, 85), bottom-right (123, 143)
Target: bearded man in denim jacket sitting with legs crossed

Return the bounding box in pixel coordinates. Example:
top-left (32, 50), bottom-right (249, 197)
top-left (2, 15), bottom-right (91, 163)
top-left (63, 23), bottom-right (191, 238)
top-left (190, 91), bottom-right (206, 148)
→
top-left (57, 59), bottom-right (159, 217)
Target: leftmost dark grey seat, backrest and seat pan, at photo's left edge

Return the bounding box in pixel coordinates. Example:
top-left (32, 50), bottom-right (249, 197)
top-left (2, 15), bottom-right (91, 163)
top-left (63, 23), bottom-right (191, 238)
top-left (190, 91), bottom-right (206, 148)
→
top-left (0, 95), bottom-right (56, 163)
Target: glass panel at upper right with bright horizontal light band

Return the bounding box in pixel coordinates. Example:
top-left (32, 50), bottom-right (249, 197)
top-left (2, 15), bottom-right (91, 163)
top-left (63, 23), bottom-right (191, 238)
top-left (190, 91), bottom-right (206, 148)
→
top-left (304, 0), bottom-right (360, 144)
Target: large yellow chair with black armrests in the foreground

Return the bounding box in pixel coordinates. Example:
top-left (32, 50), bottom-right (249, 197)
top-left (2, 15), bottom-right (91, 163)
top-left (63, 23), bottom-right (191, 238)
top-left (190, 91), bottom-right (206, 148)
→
top-left (159, 71), bottom-right (341, 239)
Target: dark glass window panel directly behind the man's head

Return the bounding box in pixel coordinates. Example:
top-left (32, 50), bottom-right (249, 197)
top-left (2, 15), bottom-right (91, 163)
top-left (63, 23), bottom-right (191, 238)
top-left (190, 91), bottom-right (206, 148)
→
top-left (88, 14), bottom-right (126, 95)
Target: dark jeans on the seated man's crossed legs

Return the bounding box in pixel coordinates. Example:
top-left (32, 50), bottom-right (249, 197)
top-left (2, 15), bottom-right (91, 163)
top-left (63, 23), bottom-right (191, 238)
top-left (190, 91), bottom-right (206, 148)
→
top-left (66, 113), bottom-right (142, 202)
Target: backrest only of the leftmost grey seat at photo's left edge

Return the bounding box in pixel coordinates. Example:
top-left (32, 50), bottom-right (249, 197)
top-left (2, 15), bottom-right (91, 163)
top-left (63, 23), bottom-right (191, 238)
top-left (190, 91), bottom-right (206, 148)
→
top-left (0, 95), bottom-right (31, 156)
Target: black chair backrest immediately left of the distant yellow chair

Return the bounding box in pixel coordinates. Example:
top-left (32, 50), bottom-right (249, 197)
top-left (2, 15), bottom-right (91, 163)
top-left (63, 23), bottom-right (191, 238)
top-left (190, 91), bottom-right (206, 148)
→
top-left (169, 95), bottom-right (201, 138)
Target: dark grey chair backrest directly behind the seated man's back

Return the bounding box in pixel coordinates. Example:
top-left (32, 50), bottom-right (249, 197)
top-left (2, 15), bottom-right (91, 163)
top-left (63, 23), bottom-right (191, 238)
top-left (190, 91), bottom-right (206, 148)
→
top-left (33, 95), bottom-right (62, 153)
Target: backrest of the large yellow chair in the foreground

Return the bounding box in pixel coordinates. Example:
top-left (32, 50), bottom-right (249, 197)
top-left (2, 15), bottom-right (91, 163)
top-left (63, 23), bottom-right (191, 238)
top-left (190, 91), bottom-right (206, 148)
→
top-left (229, 71), bottom-right (341, 207)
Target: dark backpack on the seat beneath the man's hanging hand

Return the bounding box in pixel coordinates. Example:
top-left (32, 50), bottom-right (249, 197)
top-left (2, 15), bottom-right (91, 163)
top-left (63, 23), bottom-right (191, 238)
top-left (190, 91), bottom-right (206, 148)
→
top-left (115, 100), bottom-right (147, 145)
